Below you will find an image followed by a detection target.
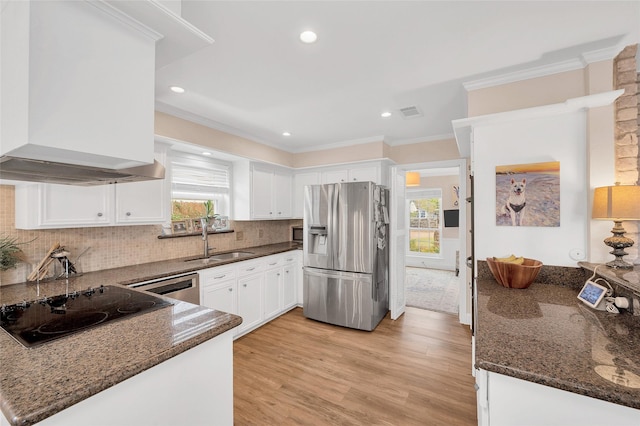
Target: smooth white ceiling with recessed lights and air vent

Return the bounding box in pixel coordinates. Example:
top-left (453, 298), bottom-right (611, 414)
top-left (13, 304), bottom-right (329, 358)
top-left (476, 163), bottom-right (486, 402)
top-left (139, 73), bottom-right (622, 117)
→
top-left (156, 0), bottom-right (640, 152)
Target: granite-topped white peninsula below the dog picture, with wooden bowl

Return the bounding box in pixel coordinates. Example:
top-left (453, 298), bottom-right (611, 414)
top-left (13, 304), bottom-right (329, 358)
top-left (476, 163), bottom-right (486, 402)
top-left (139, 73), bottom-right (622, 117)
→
top-left (475, 262), bottom-right (640, 426)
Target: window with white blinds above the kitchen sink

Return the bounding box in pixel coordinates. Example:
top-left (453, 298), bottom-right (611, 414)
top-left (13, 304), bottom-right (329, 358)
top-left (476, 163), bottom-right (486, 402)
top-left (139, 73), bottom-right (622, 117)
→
top-left (171, 153), bottom-right (231, 220)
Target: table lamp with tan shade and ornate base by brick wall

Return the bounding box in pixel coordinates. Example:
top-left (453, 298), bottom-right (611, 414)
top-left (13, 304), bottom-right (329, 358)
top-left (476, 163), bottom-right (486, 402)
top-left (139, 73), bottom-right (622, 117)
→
top-left (591, 185), bottom-right (640, 269)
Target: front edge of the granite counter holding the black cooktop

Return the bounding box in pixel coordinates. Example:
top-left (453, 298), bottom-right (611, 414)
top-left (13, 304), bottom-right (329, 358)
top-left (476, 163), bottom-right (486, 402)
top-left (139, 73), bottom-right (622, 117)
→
top-left (8, 311), bottom-right (242, 426)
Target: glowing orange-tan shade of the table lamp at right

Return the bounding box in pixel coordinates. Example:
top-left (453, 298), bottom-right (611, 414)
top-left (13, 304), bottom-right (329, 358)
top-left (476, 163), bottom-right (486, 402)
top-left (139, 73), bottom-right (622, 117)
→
top-left (591, 185), bottom-right (640, 221)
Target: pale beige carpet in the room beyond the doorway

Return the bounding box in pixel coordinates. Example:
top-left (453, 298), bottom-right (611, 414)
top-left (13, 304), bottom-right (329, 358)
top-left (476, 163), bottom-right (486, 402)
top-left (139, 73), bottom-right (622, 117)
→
top-left (405, 267), bottom-right (460, 315)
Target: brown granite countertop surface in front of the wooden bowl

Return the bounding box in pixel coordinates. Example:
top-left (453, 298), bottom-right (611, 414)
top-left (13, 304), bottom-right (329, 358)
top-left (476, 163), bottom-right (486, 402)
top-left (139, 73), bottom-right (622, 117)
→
top-left (475, 278), bottom-right (640, 409)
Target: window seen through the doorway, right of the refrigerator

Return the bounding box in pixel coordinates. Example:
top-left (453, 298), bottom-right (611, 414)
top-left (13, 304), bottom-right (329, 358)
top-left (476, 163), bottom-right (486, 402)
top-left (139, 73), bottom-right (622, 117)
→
top-left (407, 189), bottom-right (442, 255)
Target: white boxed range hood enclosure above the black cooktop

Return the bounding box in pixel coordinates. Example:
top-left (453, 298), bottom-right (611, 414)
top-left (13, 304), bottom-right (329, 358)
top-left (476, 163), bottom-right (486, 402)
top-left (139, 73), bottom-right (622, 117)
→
top-left (0, 1), bottom-right (160, 169)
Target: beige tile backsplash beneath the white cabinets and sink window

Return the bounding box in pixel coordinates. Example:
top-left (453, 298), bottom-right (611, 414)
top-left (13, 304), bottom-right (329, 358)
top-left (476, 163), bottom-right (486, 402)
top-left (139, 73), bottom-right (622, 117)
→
top-left (0, 185), bottom-right (302, 285)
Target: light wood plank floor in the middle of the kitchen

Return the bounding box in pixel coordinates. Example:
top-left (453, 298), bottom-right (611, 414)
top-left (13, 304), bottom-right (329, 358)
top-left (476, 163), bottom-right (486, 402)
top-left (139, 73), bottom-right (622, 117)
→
top-left (233, 308), bottom-right (477, 426)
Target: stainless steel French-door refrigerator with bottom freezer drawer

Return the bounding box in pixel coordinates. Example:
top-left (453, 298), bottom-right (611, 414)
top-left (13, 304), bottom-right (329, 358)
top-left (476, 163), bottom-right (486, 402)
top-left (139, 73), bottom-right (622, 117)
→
top-left (303, 182), bottom-right (389, 331)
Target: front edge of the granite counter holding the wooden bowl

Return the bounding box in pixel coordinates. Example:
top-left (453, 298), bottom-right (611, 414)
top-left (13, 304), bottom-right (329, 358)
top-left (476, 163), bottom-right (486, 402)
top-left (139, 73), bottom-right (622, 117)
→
top-left (476, 360), bottom-right (640, 409)
